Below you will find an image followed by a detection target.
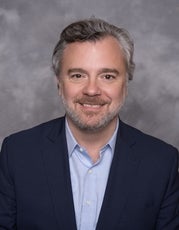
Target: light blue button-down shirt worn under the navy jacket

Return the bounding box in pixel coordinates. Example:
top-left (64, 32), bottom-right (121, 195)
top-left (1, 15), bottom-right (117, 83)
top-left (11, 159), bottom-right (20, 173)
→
top-left (66, 121), bottom-right (119, 230)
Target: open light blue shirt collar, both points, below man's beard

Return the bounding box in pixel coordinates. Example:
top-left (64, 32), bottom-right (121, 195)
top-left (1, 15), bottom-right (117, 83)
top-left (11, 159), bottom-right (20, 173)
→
top-left (65, 119), bottom-right (119, 157)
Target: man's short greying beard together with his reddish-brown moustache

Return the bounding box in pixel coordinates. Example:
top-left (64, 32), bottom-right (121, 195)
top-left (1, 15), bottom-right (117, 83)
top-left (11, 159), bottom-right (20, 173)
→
top-left (61, 95), bottom-right (125, 133)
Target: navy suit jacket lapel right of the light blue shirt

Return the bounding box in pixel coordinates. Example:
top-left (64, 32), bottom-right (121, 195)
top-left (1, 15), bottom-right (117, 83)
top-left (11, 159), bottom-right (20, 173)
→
top-left (97, 122), bottom-right (139, 230)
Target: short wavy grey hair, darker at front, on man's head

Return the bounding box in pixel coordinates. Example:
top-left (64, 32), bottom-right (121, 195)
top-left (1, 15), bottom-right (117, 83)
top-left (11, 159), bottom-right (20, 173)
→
top-left (52, 18), bottom-right (135, 80)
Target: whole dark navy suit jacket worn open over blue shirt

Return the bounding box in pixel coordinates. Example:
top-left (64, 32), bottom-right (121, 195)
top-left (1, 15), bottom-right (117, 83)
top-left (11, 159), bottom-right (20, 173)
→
top-left (0, 118), bottom-right (179, 230)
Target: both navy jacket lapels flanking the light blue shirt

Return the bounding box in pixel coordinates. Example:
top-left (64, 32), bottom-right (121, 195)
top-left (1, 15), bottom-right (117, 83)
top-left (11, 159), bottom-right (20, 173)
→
top-left (42, 117), bottom-right (139, 230)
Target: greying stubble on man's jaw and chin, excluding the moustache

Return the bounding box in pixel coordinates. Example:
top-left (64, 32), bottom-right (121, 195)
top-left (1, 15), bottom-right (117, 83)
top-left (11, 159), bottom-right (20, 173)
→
top-left (61, 95), bottom-right (125, 133)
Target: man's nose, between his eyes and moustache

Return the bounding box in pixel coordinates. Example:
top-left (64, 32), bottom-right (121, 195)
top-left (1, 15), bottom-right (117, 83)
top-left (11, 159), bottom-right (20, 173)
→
top-left (83, 78), bottom-right (101, 96)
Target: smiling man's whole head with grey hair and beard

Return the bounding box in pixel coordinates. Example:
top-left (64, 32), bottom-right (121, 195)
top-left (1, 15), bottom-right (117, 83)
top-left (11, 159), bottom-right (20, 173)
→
top-left (52, 19), bottom-right (134, 132)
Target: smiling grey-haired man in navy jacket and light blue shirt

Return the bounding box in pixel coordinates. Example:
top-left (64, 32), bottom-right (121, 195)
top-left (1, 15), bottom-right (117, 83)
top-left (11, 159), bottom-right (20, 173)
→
top-left (0, 19), bottom-right (179, 230)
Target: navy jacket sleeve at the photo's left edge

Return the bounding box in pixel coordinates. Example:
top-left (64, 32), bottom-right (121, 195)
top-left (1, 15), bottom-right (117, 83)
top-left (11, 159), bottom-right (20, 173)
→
top-left (0, 139), bottom-right (16, 230)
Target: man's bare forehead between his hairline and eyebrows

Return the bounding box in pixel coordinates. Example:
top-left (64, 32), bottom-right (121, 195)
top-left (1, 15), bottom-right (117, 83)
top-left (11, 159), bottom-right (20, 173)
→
top-left (61, 36), bottom-right (125, 69)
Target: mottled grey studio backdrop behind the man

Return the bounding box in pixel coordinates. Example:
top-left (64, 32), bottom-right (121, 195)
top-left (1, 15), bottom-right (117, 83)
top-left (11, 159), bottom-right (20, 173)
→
top-left (0, 0), bottom-right (179, 148)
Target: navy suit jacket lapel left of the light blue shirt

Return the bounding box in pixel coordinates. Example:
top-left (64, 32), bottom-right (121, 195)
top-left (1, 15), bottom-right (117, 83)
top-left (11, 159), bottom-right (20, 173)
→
top-left (42, 119), bottom-right (76, 230)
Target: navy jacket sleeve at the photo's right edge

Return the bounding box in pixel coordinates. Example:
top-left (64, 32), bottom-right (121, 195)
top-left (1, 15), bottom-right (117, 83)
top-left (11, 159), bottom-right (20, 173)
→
top-left (156, 150), bottom-right (179, 230)
